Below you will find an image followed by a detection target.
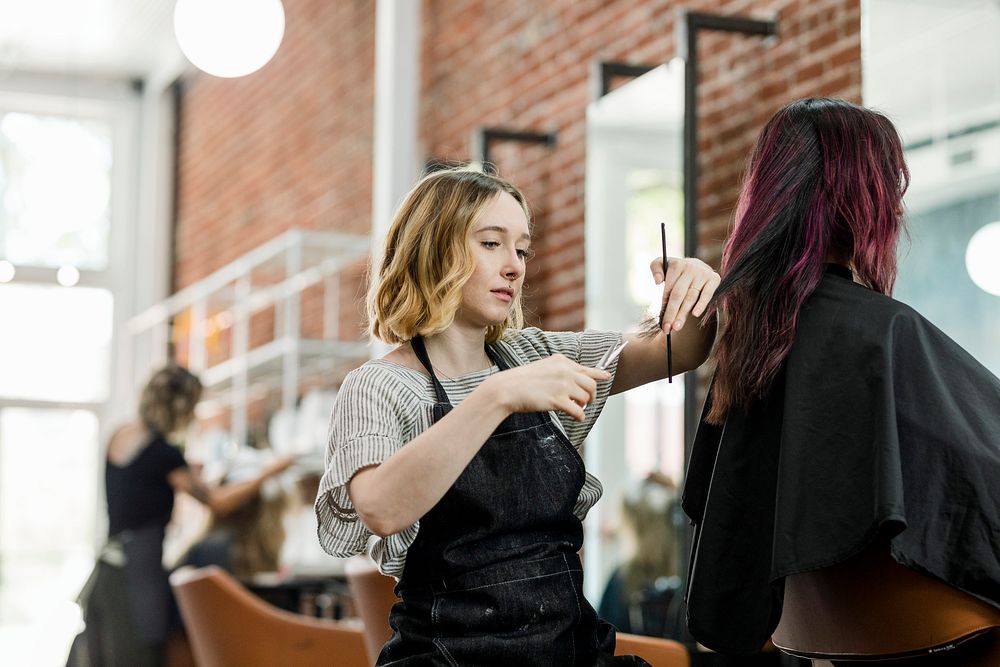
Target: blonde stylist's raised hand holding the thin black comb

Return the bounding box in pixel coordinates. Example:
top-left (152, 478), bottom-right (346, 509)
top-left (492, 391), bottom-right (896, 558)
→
top-left (649, 257), bottom-right (722, 333)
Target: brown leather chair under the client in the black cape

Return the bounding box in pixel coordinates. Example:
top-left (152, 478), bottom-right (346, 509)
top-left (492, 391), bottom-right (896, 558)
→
top-left (772, 542), bottom-right (1000, 667)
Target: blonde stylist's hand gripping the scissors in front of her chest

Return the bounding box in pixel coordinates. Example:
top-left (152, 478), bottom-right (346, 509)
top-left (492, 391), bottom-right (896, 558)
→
top-left (484, 354), bottom-right (611, 421)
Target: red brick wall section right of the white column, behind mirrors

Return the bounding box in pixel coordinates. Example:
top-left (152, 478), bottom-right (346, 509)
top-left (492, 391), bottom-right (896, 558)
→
top-left (421, 0), bottom-right (861, 329)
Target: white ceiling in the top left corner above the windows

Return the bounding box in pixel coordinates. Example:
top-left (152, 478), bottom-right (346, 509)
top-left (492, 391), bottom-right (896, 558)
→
top-left (0, 0), bottom-right (177, 78)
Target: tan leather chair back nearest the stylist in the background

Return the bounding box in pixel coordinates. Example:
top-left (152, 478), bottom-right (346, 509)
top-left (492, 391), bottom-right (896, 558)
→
top-left (170, 565), bottom-right (371, 667)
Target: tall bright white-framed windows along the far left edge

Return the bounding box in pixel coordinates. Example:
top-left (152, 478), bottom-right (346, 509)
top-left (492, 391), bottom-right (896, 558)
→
top-left (0, 91), bottom-right (127, 665)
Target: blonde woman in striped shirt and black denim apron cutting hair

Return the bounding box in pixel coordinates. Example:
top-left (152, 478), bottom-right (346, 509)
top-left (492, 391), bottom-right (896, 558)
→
top-left (316, 170), bottom-right (718, 667)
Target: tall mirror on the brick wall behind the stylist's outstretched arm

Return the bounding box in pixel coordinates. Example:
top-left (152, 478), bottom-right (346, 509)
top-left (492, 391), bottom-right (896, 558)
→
top-left (584, 60), bottom-right (684, 636)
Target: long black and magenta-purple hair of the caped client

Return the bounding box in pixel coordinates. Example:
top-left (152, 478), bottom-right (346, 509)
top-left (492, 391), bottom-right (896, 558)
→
top-left (707, 98), bottom-right (909, 424)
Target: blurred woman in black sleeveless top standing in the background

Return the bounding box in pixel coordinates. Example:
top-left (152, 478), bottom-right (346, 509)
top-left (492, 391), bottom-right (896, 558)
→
top-left (70, 365), bottom-right (293, 667)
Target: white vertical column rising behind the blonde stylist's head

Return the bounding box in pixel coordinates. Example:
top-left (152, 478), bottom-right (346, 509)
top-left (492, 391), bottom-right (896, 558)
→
top-left (371, 0), bottom-right (421, 357)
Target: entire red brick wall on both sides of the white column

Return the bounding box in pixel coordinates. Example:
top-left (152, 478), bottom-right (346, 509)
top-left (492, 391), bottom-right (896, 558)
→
top-left (175, 0), bottom-right (861, 380)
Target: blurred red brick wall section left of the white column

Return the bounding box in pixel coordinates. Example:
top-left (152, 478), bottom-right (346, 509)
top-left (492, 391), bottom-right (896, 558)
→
top-left (174, 0), bottom-right (375, 288)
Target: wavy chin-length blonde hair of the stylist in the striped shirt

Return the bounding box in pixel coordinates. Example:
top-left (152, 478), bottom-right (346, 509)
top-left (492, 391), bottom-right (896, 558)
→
top-left (368, 168), bottom-right (531, 343)
